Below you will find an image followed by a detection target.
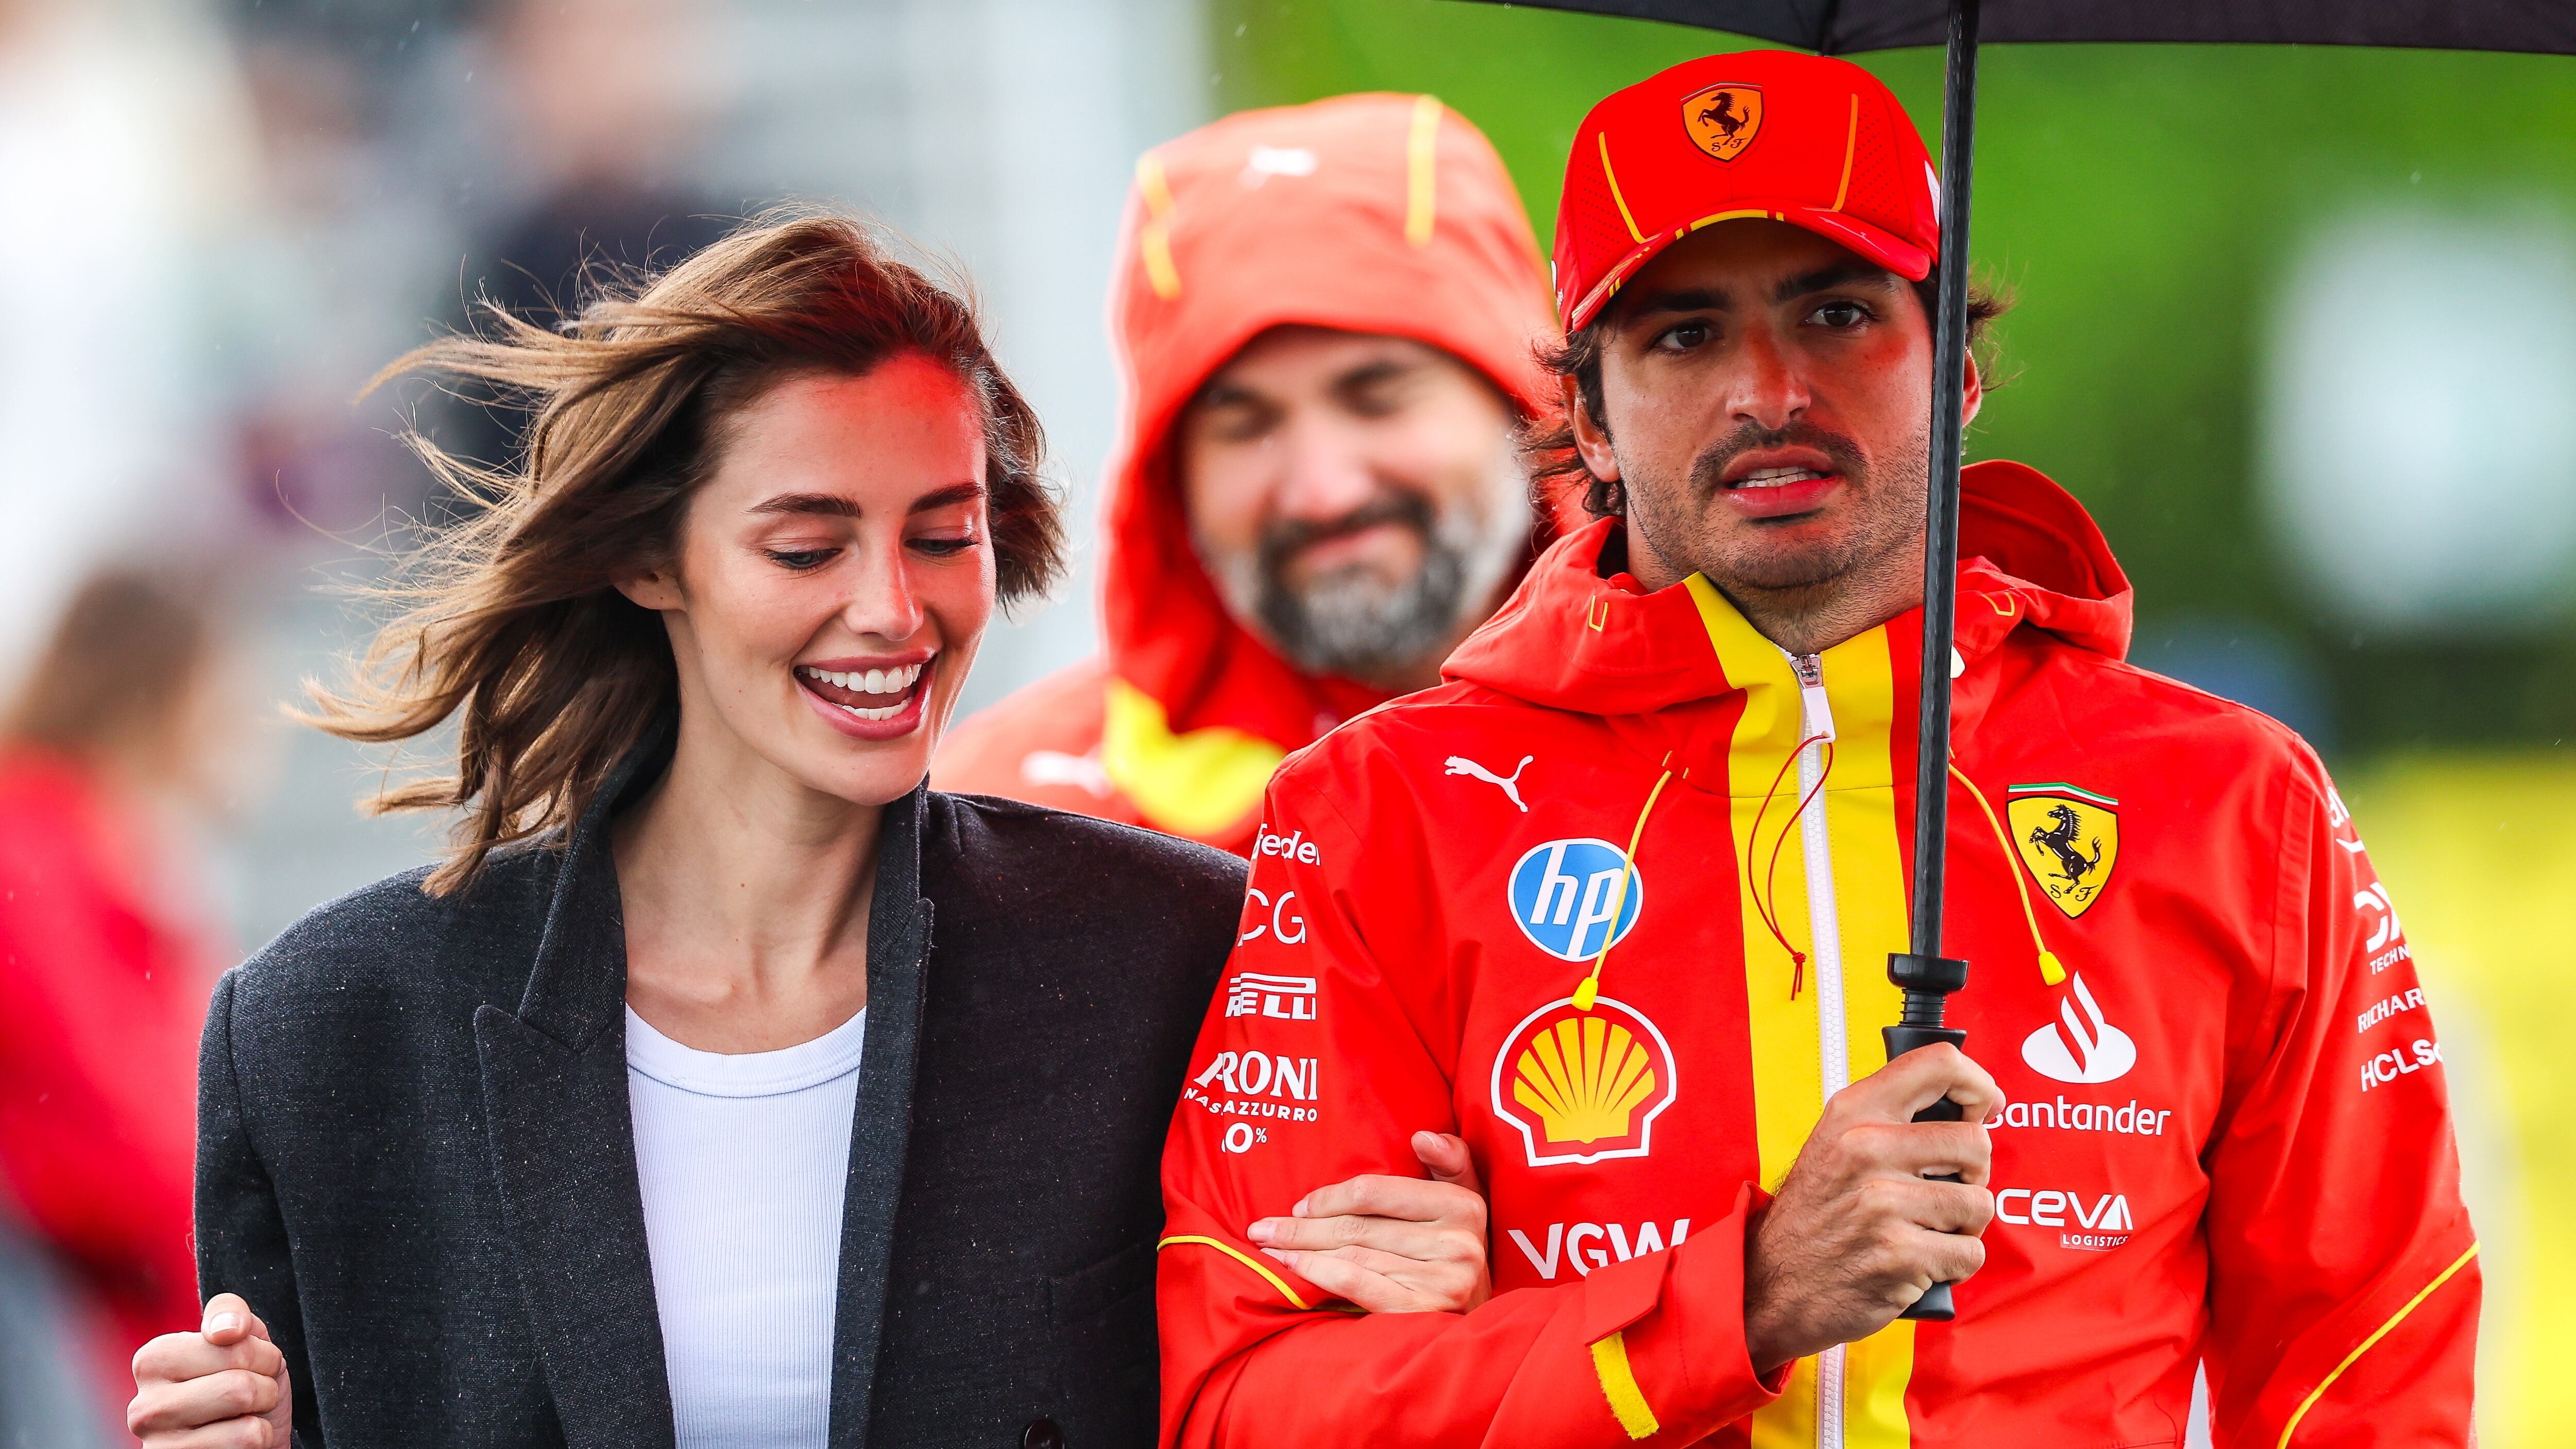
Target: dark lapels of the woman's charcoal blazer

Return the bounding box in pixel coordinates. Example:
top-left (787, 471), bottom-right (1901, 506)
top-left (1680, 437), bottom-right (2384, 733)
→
top-left (474, 722), bottom-right (930, 1449)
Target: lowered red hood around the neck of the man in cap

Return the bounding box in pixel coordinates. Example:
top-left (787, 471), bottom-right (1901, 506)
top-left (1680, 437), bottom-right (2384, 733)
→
top-left (1440, 462), bottom-right (2133, 714)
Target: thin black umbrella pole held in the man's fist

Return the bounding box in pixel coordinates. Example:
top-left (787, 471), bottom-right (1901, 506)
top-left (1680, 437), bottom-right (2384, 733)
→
top-left (1883, 0), bottom-right (1978, 1323)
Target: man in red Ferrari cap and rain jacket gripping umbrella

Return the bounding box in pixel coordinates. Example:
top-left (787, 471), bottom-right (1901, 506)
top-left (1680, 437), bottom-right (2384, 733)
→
top-left (1157, 52), bottom-right (2478, 1449)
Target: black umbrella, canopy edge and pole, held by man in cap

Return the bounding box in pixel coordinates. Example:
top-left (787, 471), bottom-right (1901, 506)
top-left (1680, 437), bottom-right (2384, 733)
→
top-left (1463, 0), bottom-right (2576, 1320)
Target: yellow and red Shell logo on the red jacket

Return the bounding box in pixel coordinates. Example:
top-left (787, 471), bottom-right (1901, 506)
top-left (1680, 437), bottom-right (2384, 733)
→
top-left (1494, 995), bottom-right (1680, 1168)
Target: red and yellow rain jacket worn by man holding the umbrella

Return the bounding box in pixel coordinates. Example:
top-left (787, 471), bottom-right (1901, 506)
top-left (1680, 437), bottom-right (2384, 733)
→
top-left (1159, 464), bottom-right (2478, 1449)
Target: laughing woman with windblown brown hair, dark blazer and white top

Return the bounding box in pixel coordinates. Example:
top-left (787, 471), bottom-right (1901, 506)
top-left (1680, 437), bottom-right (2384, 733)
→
top-left (131, 216), bottom-right (1484, 1449)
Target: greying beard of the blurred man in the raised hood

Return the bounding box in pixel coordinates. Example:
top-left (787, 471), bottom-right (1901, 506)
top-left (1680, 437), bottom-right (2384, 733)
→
top-left (1198, 464), bottom-right (1530, 683)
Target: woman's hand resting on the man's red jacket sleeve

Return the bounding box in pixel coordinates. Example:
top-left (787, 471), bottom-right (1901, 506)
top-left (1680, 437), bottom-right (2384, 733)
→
top-left (1247, 1132), bottom-right (1494, 1312)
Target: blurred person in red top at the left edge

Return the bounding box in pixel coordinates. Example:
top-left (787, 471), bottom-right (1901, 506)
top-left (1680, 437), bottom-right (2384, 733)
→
top-left (0, 570), bottom-right (247, 1403)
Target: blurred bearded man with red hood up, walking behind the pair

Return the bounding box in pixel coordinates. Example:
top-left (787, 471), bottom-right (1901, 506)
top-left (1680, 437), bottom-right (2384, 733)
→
top-left (935, 95), bottom-right (1553, 853)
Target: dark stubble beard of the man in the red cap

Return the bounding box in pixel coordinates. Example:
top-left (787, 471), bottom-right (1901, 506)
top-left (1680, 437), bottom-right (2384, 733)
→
top-left (1620, 412), bottom-right (1932, 652)
